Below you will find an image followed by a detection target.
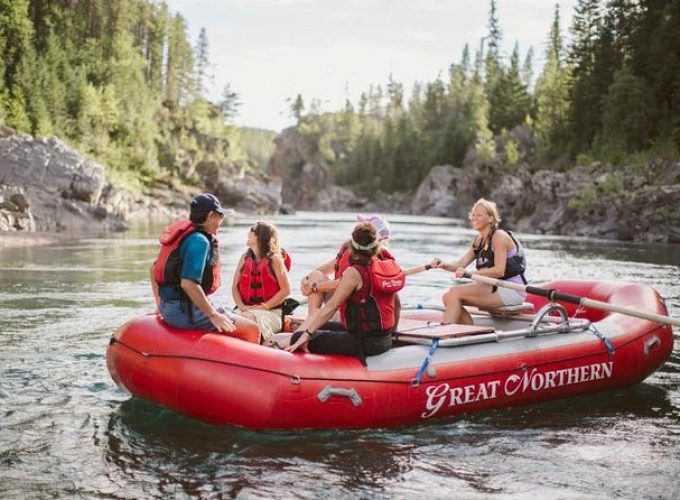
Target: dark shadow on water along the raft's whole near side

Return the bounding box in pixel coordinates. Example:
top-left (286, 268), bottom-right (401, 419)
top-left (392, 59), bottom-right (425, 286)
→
top-left (103, 384), bottom-right (677, 497)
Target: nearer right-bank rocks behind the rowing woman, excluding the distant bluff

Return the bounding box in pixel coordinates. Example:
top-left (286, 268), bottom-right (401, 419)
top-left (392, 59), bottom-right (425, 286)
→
top-left (411, 160), bottom-right (680, 243)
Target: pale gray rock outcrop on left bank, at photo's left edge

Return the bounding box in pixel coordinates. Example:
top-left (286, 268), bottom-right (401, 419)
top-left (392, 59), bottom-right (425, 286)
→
top-left (0, 128), bottom-right (190, 232)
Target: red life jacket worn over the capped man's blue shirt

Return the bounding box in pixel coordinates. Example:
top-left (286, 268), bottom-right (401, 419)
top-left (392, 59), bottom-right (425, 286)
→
top-left (153, 220), bottom-right (221, 295)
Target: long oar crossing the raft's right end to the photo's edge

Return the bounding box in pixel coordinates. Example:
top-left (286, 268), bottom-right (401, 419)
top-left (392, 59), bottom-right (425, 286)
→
top-left (465, 272), bottom-right (680, 326)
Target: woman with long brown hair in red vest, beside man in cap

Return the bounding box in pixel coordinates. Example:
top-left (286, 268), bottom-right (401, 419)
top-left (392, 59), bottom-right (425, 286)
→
top-left (231, 222), bottom-right (291, 344)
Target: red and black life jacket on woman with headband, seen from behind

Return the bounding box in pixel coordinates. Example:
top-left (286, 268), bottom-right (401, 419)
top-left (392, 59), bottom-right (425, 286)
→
top-left (340, 257), bottom-right (406, 334)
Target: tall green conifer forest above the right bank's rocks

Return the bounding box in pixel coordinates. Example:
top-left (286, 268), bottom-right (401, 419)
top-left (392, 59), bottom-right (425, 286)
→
top-left (286, 0), bottom-right (680, 195)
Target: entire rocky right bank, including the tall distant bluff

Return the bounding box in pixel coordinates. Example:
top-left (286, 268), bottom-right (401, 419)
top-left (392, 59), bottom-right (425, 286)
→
top-left (270, 127), bottom-right (680, 242)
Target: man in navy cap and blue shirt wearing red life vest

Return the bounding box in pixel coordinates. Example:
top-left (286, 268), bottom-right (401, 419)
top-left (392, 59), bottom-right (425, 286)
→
top-left (151, 193), bottom-right (257, 333)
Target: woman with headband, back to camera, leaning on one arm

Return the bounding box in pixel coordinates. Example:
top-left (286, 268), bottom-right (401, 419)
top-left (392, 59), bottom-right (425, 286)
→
top-left (286, 222), bottom-right (405, 362)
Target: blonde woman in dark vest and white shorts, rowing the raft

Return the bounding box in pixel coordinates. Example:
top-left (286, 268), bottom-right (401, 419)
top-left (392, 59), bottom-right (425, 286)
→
top-left (431, 198), bottom-right (527, 325)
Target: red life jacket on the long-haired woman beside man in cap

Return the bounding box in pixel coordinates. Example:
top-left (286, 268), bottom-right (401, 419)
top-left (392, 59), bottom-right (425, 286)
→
top-left (238, 249), bottom-right (290, 306)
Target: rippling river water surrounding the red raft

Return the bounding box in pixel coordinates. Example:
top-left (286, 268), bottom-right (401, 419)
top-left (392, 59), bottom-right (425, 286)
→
top-left (0, 213), bottom-right (680, 499)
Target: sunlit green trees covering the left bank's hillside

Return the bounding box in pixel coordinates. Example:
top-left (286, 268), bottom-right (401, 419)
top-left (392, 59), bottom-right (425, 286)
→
top-left (0, 0), bottom-right (252, 189)
